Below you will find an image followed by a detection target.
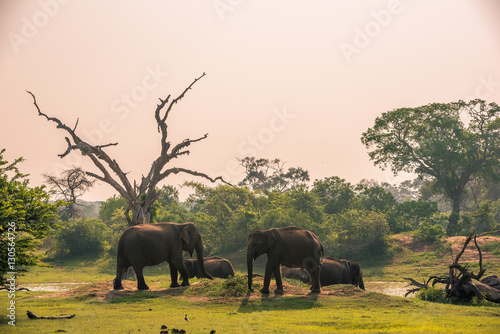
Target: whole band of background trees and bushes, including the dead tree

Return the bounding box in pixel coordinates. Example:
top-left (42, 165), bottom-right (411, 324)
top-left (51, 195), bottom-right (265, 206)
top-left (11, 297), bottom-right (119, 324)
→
top-left (0, 73), bottom-right (500, 284)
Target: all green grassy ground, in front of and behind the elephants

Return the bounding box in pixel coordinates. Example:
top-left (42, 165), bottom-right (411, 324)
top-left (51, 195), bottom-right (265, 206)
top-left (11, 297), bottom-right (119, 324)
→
top-left (0, 235), bottom-right (500, 333)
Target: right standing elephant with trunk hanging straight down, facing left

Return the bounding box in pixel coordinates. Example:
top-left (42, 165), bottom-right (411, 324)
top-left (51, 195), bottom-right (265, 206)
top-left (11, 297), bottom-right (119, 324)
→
top-left (247, 226), bottom-right (324, 294)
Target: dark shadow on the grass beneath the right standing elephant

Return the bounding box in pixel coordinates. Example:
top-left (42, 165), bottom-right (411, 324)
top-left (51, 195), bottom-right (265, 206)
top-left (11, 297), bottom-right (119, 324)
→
top-left (238, 292), bottom-right (318, 313)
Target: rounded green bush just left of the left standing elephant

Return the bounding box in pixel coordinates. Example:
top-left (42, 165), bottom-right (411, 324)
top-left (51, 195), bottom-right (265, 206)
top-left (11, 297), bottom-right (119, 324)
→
top-left (55, 219), bottom-right (109, 257)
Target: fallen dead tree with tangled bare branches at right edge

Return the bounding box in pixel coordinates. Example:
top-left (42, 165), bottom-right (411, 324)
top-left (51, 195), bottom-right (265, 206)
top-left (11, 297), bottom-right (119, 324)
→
top-left (405, 231), bottom-right (500, 303)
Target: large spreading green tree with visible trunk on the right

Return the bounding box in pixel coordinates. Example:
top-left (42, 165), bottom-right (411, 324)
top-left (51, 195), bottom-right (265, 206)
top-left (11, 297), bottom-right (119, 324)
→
top-left (361, 100), bottom-right (500, 235)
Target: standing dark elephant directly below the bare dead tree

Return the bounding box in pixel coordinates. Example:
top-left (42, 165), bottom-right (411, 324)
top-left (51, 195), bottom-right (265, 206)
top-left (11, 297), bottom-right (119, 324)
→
top-left (113, 223), bottom-right (213, 290)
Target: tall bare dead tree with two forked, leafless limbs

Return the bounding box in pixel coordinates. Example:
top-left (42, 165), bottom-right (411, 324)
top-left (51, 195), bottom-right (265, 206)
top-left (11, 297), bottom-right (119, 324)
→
top-left (28, 73), bottom-right (225, 226)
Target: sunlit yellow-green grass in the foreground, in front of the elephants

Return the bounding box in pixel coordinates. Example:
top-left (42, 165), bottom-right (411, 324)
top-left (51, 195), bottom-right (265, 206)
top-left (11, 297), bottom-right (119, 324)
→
top-left (0, 280), bottom-right (500, 333)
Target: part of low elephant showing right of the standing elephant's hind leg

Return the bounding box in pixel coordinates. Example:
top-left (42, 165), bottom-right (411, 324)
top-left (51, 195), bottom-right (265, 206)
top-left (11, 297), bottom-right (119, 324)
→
top-left (320, 257), bottom-right (365, 290)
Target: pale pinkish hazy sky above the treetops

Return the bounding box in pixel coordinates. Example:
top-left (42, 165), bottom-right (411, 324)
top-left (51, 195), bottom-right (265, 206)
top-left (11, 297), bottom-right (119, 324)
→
top-left (0, 0), bottom-right (500, 201)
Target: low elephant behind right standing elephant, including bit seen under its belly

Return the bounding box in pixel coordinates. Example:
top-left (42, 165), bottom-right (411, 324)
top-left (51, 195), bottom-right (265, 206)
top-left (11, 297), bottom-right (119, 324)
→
top-left (281, 257), bottom-right (365, 290)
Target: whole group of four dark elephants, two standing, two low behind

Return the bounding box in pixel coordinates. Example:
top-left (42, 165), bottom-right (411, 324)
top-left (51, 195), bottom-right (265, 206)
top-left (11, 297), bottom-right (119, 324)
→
top-left (113, 223), bottom-right (364, 294)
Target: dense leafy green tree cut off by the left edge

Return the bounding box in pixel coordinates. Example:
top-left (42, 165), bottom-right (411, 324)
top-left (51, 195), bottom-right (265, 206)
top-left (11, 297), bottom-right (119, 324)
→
top-left (0, 149), bottom-right (62, 284)
